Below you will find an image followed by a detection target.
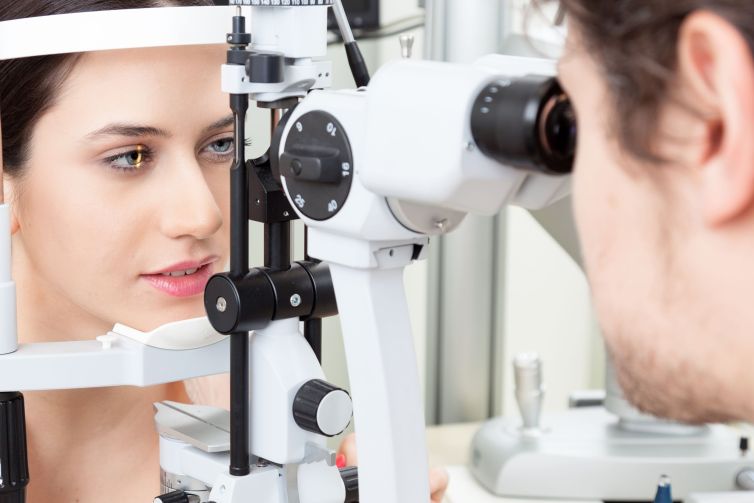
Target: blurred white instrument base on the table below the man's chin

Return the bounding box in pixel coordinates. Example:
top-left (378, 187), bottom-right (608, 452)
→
top-left (470, 407), bottom-right (754, 501)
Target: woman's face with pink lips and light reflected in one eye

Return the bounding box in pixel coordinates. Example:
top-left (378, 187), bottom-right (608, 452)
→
top-left (14, 46), bottom-right (233, 337)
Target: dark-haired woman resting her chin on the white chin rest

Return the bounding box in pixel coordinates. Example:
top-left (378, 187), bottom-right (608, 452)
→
top-left (0, 0), bottom-right (445, 503)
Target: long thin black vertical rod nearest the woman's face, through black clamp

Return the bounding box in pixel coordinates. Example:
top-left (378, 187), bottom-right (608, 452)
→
top-left (230, 94), bottom-right (251, 476)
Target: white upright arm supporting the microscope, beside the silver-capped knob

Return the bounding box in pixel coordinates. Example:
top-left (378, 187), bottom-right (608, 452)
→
top-left (330, 263), bottom-right (429, 503)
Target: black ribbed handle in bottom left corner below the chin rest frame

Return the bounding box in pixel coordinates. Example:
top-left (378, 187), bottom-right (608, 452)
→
top-left (0, 392), bottom-right (29, 503)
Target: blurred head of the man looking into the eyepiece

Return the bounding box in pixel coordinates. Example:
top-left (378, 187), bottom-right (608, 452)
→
top-left (560, 0), bottom-right (754, 422)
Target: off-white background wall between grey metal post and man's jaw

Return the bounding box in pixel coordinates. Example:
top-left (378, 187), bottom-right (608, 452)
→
top-left (503, 208), bottom-right (604, 414)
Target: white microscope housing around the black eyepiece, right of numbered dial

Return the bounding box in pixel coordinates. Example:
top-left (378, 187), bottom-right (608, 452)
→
top-left (360, 55), bottom-right (570, 215)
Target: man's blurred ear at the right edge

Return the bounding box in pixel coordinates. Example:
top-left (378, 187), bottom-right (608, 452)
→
top-left (678, 11), bottom-right (754, 226)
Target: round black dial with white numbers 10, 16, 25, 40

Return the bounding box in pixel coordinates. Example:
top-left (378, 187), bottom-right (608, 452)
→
top-left (280, 111), bottom-right (353, 220)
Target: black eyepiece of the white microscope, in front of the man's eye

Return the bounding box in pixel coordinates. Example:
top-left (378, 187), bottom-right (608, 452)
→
top-left (471, 75), bottom-right (577, 175)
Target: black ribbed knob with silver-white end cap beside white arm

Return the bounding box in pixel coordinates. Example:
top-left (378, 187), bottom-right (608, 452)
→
top-left (293, 379), bottom-right (353, 437)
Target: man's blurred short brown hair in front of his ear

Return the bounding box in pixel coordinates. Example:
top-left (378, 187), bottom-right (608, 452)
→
top-left (561, 0), bottom-right (754, 161)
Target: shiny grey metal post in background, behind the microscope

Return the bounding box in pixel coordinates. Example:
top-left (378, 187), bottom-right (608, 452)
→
top-left (426, 0), bottom-right (511, 424)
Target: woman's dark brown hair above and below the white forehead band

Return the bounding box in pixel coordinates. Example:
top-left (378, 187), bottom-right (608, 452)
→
top-left (0, 0), bottom-right (213, 177)
